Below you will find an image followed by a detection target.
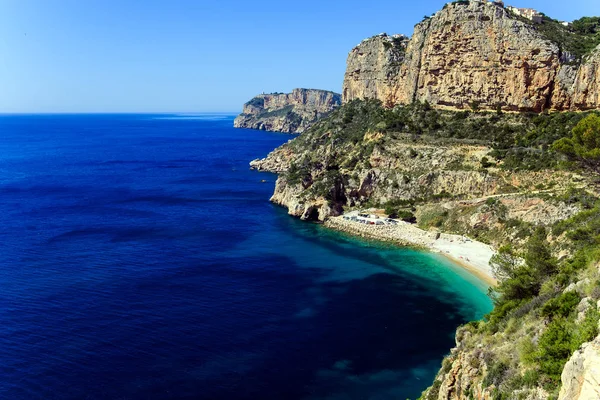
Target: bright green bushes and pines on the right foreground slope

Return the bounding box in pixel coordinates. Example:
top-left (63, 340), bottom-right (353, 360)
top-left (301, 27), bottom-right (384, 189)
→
top-left (481, 191), bottom-right (600, 392)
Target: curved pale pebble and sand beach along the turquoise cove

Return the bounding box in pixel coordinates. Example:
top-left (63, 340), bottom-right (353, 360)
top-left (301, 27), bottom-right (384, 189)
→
top-left (325, 217), bottom-right (497, 286)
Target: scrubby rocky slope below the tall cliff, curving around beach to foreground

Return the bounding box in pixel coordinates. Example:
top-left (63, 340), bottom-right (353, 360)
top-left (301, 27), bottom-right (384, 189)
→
top-left (251, 98), bottom-right (600, 400)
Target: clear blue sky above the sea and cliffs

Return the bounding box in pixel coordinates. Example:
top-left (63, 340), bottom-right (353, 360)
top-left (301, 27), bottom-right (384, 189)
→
top-left (0, 0), bottom-right (600, 113)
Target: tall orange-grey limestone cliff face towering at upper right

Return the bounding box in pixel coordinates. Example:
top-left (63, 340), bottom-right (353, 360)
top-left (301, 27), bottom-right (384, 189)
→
top-left (343, 0), bottom-right (600, 112)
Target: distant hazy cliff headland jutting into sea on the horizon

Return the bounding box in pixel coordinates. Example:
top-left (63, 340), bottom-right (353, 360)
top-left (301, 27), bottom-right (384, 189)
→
top-left (233, 89), bottom-right (341, 133)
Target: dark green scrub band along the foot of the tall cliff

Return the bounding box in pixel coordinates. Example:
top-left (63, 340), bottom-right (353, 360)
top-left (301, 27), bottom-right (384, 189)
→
top-left (297, 100), bottom-right (597, 171)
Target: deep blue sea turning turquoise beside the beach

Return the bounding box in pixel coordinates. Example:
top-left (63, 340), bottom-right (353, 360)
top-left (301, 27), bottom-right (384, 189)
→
top-left (0, 114), bottom-right (491, 400)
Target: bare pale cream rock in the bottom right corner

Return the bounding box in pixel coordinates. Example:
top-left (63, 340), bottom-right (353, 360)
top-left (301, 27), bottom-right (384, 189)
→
top-left (558, 336), bottom-right (600, 400)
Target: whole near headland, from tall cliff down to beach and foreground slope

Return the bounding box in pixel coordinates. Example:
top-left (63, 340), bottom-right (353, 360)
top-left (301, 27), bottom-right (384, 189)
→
top-left (251, 0), bottom-right (600, 400)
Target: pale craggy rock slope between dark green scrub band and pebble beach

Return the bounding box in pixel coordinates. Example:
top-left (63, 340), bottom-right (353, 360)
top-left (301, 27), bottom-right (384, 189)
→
top-left (250, 125), bottom-right (578, 223)
